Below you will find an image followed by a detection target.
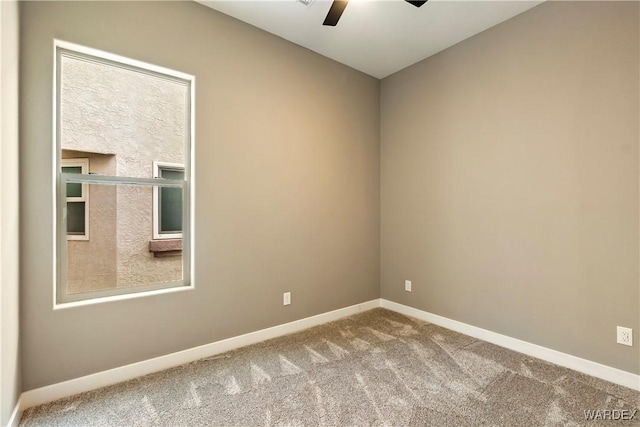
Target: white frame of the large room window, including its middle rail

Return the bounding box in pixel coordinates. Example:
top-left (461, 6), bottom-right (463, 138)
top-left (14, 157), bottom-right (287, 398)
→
top-left (52, 39), bottom-right (196, 310)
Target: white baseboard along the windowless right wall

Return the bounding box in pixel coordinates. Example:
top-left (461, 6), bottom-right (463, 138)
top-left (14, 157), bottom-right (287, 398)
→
top-left (380, 299), bottom-right (640, 391)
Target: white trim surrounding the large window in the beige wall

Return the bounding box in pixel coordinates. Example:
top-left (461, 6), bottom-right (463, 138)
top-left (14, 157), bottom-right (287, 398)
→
top-left (51, 39), bottom-right (196, 310)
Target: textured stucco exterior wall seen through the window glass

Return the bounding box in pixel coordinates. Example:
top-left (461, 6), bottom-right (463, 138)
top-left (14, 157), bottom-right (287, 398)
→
top-left (60, 51), bottom-right (188, 293)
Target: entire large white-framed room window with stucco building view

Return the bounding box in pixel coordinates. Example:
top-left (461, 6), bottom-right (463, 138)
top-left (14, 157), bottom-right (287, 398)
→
top-left (54, 40), bottom-right (195, 304)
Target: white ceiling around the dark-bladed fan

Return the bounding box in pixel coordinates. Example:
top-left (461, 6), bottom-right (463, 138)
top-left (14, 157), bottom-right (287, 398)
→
top-left (196, 0), bottom-right (543, 79)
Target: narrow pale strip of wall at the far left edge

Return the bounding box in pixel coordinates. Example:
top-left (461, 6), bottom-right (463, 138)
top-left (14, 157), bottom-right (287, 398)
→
top-left (0, 1), bottom-right (21, 426)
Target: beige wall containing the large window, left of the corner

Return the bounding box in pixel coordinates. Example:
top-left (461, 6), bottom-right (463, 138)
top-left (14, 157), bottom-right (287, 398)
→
top-left (20, 2), bottom-right (379, 390)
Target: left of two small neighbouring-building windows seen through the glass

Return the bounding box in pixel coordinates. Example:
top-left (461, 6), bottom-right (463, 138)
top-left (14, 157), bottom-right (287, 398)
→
top-left (61, 159), bottom-right (89, 240)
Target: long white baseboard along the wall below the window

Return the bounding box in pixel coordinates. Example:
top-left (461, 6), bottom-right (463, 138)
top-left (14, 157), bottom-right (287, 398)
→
top-left (18, 299), bottom-right (380, 412)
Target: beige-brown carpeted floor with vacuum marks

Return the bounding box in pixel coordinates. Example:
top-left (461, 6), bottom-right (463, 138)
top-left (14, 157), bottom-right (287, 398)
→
top-left (20, 309), bottom-right (640, 427)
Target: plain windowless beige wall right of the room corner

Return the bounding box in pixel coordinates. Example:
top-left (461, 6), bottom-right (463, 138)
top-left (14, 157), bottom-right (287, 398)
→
top-left (381, 2), bottom-right (640, 373)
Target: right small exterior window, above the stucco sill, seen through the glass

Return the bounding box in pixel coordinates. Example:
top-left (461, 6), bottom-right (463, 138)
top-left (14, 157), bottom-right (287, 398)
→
top-left (153, 162), bottom-right (184, 239)
